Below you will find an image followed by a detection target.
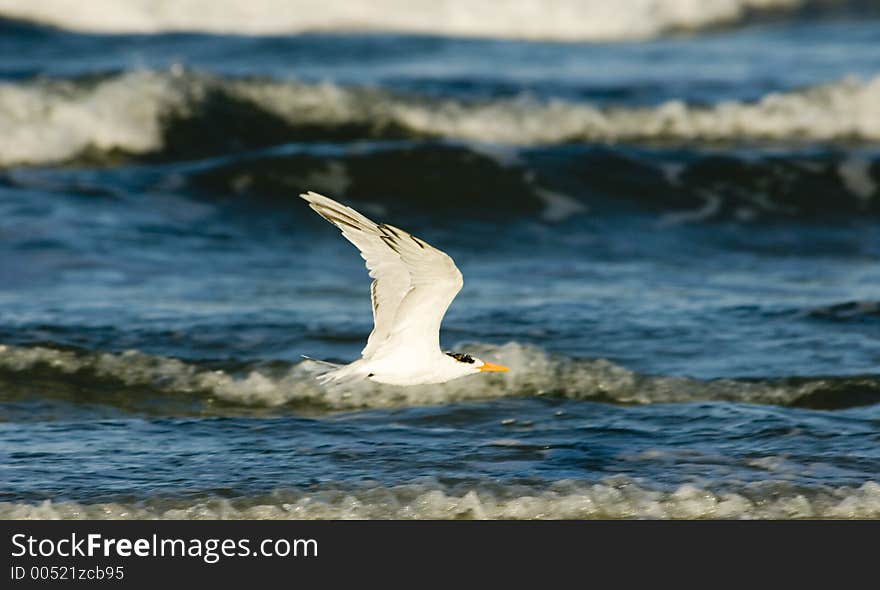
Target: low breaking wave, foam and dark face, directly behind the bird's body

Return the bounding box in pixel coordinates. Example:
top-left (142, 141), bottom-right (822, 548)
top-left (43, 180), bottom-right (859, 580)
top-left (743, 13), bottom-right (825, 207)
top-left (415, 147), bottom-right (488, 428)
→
top-left (0, 342), bottom-right (880, 415)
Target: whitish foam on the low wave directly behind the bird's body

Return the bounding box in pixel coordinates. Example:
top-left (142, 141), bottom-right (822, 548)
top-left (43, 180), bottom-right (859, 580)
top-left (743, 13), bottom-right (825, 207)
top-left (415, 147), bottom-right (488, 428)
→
top-left (0, 342), bottom-right (868, 411)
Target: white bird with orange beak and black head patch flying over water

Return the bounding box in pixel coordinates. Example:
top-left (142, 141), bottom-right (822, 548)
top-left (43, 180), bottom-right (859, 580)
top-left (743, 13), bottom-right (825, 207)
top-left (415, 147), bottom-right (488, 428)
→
top-left (300, 192), bottom-right (509, 385)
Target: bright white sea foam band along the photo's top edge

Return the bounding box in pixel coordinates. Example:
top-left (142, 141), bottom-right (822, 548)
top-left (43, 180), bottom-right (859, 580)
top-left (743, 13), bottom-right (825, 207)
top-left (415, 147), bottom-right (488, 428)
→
top-left (0, 0), bottom-right (812, 41)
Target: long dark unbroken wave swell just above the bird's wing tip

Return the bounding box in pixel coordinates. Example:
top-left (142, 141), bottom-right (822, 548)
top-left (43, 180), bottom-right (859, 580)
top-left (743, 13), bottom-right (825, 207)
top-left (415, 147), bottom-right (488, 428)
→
top-left (177, 142), bottom-right (880, 225)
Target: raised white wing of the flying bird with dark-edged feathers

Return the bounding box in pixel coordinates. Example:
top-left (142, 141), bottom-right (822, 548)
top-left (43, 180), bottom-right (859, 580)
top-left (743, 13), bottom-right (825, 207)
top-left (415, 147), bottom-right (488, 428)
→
top-left (300, 192), bottom-right (464, 358)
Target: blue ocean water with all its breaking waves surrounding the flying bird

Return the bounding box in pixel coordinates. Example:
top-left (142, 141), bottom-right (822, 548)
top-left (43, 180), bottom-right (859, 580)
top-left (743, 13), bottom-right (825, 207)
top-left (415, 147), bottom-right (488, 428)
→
top-left (0, 0), bottom-right (880, 519)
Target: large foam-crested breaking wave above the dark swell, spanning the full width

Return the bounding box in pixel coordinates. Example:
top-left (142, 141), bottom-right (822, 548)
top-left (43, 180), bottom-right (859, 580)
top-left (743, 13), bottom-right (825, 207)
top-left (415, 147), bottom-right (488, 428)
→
top-left (0, 68), bottom-right (880, 170)
